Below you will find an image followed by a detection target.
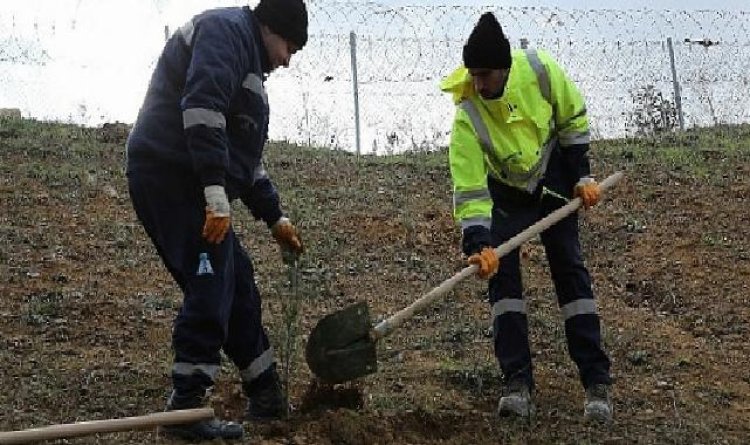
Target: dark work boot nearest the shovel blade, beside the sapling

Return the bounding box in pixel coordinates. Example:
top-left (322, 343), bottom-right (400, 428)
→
top-left (242, 366), bottom-right (286, 420)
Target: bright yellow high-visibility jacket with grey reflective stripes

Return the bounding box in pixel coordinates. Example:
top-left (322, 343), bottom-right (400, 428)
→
top-left (440, 49), bottom-right (589, 229)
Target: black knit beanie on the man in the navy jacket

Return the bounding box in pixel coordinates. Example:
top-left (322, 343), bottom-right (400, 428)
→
top-left (254, 0), bottom-right (307, 48)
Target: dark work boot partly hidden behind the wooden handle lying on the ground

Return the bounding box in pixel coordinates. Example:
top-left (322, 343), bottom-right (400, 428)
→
top-left (160, 390), bottom-right (245, 441)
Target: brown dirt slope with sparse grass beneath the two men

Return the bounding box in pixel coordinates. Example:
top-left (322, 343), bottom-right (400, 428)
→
top-left (0, 120), bottom-right (750, 445)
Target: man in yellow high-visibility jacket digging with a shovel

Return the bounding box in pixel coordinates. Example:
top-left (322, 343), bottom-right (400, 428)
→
top-left (441, 13), bottom-right (612, 422)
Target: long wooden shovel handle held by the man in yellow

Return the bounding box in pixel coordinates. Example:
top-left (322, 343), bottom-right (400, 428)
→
top-left (370, 172), bottom-right (624, 341)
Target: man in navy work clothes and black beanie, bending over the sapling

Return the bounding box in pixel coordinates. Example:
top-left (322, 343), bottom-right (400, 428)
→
top-left (127, 0), bottom-right (308, 440)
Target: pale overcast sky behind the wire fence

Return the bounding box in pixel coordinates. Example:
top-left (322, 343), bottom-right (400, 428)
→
top-left (0, 0), bottom-right (750, 150)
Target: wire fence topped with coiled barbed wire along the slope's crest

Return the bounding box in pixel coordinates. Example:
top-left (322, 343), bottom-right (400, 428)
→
top-left (0, 0), bottom-right (750, 153)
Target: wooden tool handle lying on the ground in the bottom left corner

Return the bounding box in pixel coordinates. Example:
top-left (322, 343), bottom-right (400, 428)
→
top-left (0, 408), bottom-right (214, 445)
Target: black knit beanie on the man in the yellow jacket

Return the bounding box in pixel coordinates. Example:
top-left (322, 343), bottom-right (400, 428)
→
top-left (464, 12), bottom-right (511, 69)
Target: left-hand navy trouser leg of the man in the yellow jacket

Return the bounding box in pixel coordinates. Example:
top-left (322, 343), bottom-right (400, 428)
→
top-left (489, 196), bottom-right (536, 387)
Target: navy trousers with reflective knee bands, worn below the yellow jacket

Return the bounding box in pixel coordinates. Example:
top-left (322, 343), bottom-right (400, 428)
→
top-left (489, 153), bottom-right (610, 387)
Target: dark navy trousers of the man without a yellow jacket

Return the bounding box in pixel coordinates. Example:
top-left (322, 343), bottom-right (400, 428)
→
top-left (128, 169), bottom-right (272, 387)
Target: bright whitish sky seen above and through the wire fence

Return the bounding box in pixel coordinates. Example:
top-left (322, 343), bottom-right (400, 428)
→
top-left (0, 0), bottom-right (750, 137)
